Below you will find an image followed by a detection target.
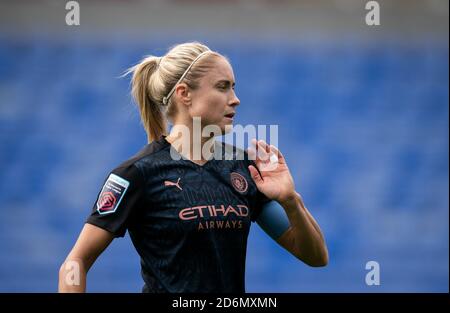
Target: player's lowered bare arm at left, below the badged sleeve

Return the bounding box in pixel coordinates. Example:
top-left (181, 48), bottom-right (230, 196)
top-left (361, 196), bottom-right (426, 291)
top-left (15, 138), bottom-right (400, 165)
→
top-left (58, 223), bottom-right (114, 292)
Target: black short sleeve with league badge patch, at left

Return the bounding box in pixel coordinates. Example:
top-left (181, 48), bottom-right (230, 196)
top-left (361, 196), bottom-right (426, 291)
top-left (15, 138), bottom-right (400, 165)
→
top-left (86, 164), bottom-right (143, 237)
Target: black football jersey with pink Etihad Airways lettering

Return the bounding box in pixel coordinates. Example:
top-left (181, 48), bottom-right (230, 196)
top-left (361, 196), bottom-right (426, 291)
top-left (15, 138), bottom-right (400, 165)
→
top-left (87, 136), bottom-right (269, 293)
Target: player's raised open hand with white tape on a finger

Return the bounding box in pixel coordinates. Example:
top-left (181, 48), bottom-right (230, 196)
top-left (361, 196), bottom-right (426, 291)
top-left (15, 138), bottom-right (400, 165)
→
top-left (247, 139), bottom-right (296, 203)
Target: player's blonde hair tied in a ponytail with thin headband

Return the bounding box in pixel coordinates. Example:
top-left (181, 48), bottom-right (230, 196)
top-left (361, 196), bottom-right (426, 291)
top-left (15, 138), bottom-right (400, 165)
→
top-left (125, 42), bottom-right (223, 143)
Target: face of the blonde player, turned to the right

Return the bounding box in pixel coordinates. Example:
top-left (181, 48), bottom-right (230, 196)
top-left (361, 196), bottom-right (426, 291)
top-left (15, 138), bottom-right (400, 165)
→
top-left (188, 57), bottom-right (240, 134)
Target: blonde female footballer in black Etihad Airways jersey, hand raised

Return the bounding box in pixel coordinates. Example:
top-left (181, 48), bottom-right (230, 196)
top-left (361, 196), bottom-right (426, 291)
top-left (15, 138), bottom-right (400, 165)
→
top-left (59, 42), bottom-right (328, 293)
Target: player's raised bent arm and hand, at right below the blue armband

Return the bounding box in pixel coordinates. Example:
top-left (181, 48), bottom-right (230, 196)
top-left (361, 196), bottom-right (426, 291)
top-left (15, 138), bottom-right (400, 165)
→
top-left (248, 140), bottom-right (328, 266)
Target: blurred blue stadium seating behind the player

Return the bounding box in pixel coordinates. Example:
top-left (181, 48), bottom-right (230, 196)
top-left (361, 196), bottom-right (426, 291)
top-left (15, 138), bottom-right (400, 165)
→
top-left (0, 39), bottom-right (449, 292)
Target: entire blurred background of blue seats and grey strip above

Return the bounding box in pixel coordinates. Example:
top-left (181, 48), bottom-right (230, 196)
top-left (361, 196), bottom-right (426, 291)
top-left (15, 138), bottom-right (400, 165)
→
top-left (0, 0), bottom-right (449, 292)
